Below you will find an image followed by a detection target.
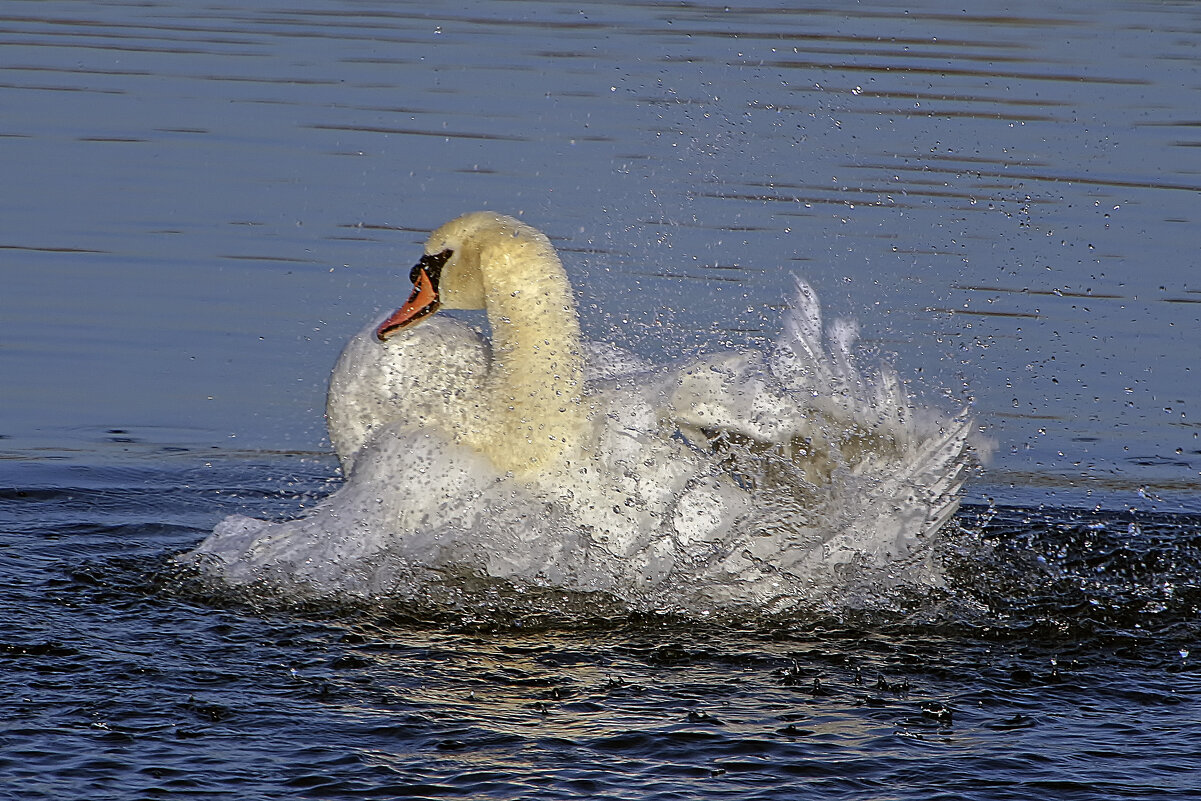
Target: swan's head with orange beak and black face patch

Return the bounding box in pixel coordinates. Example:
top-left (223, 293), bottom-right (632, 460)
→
top-left (376, 211), bottom-right (550, 341)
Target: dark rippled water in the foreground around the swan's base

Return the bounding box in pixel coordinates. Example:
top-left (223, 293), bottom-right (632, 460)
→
top-left (0, 454), bottom-right (1201, 799)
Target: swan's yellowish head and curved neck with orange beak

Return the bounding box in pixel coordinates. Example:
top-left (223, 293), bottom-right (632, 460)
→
top-left (333, 211), bottom-right (587, 476)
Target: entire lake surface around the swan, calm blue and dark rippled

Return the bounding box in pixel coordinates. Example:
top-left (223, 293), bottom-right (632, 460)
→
top-left (0, 1), bottom-right (1201, 800)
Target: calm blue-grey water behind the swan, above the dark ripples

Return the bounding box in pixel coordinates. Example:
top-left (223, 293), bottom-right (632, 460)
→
top-left (0, 2), bottom-right (1201, 506)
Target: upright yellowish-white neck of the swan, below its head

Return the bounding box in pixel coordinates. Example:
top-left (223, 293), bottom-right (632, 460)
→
top-left (470, 237), bottom-right (585, 474)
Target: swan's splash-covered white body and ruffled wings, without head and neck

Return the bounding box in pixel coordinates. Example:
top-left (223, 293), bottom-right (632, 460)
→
top-left (183, 280), bottom-right (973, 615)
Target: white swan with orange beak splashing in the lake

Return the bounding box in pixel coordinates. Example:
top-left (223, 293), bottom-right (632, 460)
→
top-left (186, 213), bottom-right (970, 609)
